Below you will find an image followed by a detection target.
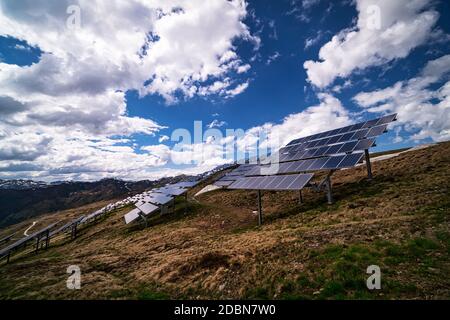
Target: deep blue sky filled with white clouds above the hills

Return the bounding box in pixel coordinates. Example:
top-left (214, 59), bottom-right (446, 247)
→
top-left (0, 0), bottom-right (450, 180)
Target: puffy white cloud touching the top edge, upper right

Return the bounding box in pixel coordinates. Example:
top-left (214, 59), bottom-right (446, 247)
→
top-left (304, 0), bottom-right (439, 88)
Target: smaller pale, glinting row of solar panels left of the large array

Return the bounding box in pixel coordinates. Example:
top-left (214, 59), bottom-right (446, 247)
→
top-left (124, 181), bottom-right (199, 224)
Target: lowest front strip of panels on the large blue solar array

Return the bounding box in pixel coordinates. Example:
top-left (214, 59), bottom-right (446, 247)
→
top-left (229, 174), bottom-right (313, 190)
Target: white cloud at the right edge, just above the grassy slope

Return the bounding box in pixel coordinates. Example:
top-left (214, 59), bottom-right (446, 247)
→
top-left (354, 55), bottom-right (450, 141)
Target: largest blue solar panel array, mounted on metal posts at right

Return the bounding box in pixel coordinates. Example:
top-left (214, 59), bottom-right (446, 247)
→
top-left (219, 114), bottom-right (396, 190)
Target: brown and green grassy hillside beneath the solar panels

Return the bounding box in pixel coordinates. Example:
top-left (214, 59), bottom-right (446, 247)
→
top-left (0, 143), bottom-right (450, 299)
